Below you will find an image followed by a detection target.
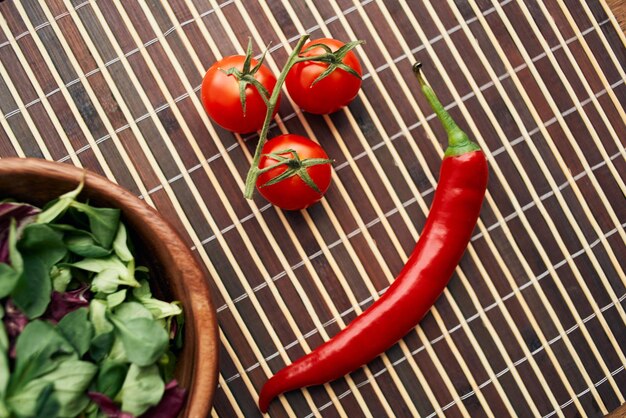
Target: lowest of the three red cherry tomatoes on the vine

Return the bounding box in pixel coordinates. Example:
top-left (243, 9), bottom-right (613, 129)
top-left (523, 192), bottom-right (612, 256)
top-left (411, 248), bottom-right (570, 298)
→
top-left (256, 134), bottom-right (331, 210)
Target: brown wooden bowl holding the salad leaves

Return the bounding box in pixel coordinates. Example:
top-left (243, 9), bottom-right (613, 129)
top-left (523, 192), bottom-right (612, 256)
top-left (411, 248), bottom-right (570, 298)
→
top-left (0, 158), bottom-right (219, 418)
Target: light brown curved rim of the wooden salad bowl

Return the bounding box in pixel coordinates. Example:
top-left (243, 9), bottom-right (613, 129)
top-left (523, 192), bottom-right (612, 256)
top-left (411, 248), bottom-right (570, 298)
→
top-left (0, 157), bottom-right (219, 417)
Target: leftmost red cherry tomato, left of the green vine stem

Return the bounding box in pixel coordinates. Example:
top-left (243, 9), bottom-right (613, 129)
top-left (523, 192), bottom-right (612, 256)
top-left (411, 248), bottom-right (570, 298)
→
top-left (201, 55), bottom-right (280, 133)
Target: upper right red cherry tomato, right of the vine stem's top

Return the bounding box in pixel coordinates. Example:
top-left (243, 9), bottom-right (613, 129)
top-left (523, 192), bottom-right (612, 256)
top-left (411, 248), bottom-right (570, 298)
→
top-left (285, 38), bottom-right (363, 115)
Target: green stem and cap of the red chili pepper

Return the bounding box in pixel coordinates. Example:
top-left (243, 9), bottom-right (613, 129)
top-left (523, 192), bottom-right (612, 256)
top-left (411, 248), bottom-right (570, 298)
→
top-left (413, 62), bottom-right (480, 157)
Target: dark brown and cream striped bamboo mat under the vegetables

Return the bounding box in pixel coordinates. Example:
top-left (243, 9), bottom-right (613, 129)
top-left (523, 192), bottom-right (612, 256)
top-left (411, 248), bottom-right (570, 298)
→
top-left (0, 0), bottom-right (626, 417)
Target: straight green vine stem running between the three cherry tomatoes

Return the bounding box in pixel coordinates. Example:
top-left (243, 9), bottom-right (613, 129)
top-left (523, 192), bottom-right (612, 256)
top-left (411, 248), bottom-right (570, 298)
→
top-left (244, 35), bottom-right (309, 199)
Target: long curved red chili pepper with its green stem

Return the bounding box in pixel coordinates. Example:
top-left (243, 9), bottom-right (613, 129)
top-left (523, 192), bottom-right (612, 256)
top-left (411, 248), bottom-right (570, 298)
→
top-left (259, 63), bottom-right (488, 412)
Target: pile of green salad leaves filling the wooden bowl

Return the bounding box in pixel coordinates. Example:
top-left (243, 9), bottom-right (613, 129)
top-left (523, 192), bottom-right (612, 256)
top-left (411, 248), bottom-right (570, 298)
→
top-left (0, 188), bottom-right (184, 418)
